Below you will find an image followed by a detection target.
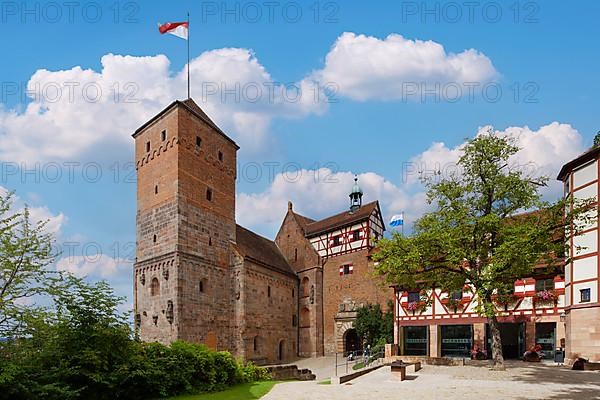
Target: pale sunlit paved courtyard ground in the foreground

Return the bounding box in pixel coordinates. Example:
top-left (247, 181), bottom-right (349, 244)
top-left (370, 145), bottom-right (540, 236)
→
top-left (263, 361), bottom-right (600, 400)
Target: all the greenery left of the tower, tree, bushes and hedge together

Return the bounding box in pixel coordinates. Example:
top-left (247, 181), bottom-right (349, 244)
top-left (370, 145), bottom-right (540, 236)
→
top-left (0, 191), bottom-right (270, 400)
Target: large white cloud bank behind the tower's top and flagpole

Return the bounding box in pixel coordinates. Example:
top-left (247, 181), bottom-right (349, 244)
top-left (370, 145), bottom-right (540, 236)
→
top-left (0, 48), bottom-right (326, 162)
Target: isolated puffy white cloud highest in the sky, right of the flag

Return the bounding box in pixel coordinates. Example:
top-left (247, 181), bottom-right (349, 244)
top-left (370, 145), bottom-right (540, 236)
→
top-left (311, 32), bottom-right (498, 101)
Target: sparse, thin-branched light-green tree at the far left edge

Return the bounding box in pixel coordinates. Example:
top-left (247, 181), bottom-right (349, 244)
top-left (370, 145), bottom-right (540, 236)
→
top-left (0, 193), bottom-right (61, 337)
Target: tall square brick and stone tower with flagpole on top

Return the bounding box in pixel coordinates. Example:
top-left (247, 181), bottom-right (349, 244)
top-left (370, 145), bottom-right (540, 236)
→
top-left (133, 99), bottom-right (239, 351)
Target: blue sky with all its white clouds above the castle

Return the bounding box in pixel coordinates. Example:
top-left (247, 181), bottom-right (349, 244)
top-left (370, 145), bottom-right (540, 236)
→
top-left (0, 1), bottom-right (600, 306)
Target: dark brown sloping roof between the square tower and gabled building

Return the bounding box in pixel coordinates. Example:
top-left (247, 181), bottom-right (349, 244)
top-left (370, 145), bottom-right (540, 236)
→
top-left (235, 225), bottom-right (296, 277)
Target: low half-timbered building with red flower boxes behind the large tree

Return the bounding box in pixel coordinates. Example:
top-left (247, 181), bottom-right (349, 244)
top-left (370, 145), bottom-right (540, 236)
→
top-left (394, 273), bottom-right (565, 359)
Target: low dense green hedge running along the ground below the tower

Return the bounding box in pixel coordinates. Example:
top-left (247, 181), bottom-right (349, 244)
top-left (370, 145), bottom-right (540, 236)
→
top-left (0, 340), bottom-right (270, 400)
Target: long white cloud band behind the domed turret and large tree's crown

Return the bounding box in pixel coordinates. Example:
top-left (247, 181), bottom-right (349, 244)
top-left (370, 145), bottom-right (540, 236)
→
top-left (236, 122), bottom-right (584, 237)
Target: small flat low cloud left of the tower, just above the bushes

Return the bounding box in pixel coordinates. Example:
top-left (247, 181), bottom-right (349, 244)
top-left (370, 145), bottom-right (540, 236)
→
top-left (56, 254), bottom-right (131, 279)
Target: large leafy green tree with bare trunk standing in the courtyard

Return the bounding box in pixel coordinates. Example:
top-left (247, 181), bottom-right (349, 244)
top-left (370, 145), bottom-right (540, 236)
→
top-left (374, 132), bottom-right (589, 369)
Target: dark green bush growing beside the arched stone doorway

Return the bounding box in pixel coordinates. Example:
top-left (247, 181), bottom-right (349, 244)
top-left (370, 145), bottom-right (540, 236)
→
top-left (354, 301), bottom-right (394, 354)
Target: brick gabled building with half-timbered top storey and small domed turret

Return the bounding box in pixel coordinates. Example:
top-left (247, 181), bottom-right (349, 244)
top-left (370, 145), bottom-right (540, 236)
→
top-left (275, 179), bottom-right (393, 356)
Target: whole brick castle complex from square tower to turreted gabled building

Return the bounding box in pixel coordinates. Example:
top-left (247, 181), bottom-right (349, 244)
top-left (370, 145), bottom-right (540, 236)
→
top-left (133, 99), bottom-right (393, 364)
